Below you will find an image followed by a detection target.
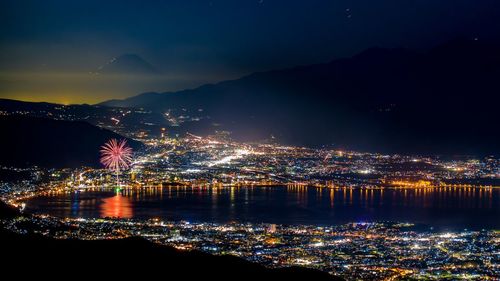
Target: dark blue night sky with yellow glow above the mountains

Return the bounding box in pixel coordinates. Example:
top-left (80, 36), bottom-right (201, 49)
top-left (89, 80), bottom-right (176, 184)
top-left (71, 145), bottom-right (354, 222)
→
top-left (0, 0), bottom-right (500, 103)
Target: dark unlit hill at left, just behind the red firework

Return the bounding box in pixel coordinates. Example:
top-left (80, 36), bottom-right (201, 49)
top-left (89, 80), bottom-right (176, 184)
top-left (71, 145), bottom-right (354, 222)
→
top-left (0, 116), bottom-right (142, 168)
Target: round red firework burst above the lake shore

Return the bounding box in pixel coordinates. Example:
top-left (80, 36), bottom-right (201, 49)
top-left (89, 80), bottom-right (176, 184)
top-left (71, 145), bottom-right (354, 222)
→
top-left (101, 139), bottom-right (132, 173)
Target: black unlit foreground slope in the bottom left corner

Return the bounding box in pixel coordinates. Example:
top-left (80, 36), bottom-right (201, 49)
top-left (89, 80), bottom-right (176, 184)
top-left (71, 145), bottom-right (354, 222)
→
top-left (0, 203), bottom-right (342, 280)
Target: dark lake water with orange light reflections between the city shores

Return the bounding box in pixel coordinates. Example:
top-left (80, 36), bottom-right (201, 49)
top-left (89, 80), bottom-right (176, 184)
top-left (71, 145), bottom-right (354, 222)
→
top-left (27, 186), bottom-right (500, 228)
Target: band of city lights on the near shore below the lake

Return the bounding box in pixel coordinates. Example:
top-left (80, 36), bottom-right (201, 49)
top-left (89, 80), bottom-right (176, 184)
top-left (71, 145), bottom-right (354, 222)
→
top-left (3, 213), bottom-right (500, 280)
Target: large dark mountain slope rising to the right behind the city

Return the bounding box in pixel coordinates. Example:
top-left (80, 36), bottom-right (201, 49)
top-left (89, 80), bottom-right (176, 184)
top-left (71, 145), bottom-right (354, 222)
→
top-left (101, 40), bottom-right (500, 154)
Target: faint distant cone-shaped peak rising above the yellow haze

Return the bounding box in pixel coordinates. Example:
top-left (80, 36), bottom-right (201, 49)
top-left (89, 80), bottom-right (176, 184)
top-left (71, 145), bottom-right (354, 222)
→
top-left (95, 54), bottom-right (160, 75)
